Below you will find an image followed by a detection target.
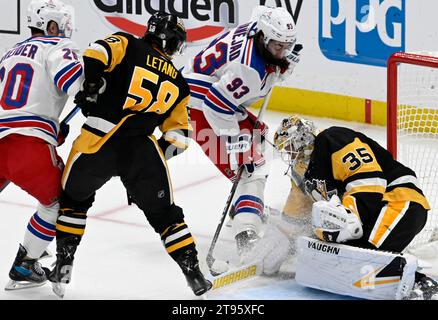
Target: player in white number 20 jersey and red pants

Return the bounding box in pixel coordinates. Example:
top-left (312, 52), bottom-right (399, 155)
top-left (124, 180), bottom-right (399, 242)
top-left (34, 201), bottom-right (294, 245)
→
top-left (0, 0), bottom-right (82, 290)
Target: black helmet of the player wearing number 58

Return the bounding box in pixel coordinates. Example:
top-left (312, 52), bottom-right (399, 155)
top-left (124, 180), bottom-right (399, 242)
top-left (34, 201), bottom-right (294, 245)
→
top-left (145, 12), bottom-right (187, 56)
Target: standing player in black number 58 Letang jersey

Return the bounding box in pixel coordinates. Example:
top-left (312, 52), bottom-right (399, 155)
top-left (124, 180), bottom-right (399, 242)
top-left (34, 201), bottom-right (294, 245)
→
top-left (49, 12), bottom-right (211, 296)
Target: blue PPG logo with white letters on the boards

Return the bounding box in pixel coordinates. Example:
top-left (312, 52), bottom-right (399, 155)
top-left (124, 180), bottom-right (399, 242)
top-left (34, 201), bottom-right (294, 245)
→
top-left (319, 0), bottom-right (406, 67)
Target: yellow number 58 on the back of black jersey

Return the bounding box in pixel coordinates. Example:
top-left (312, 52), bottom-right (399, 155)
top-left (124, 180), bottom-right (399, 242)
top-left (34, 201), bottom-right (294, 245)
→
top-left (123, 66), bottom-right (179, 114)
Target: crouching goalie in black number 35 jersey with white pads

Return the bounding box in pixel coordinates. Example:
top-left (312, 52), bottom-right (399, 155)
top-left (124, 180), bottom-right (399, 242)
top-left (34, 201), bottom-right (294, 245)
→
top-left (274, 116), bottom-right (438, 299)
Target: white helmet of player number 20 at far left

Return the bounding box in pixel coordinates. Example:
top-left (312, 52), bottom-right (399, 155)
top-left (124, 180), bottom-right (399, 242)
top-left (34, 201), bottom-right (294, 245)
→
top-left (27, 0), bottom-right (74, 38)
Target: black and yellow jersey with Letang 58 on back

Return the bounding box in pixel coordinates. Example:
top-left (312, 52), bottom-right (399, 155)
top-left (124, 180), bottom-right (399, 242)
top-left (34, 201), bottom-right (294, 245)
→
top-left (75, 32), bottom-right (192, 153)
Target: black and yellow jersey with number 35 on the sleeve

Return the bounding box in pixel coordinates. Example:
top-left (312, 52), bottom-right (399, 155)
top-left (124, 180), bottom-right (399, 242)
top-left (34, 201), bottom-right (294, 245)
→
top-left (305, 127), bottom-right (430, 210)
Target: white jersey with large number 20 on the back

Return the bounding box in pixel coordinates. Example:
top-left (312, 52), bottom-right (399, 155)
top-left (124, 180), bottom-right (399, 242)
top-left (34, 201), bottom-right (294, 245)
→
top-left (0, 36), bottom-right (83, 146)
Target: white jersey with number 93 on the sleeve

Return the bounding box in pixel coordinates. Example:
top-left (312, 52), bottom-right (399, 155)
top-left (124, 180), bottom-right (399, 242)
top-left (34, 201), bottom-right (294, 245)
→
top-left (183, 22), bottom-right (278, 136)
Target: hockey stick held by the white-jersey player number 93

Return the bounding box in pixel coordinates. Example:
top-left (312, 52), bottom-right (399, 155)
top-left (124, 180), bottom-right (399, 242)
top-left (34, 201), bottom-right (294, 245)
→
top-left (206, 88), bottom-right (272, 276)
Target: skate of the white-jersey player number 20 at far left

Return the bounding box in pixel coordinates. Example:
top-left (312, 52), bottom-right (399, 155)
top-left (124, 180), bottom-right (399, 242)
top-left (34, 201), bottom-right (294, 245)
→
top-left (5, 244), bottom-right (47, 290)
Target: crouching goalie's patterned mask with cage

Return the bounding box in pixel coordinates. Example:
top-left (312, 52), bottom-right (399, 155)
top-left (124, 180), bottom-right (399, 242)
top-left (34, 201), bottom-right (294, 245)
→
top-left (274, 115), bottom-right (319, 168)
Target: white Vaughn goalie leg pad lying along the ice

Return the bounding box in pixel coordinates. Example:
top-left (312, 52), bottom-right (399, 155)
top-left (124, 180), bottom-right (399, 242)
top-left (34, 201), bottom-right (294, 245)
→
top-left (295, 237), bottom-right (418, 300)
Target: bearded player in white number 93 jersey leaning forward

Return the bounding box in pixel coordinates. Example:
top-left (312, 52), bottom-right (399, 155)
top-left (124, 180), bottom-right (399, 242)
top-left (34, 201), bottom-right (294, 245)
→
top-left (183, 6), bottom-right (302, 268)
